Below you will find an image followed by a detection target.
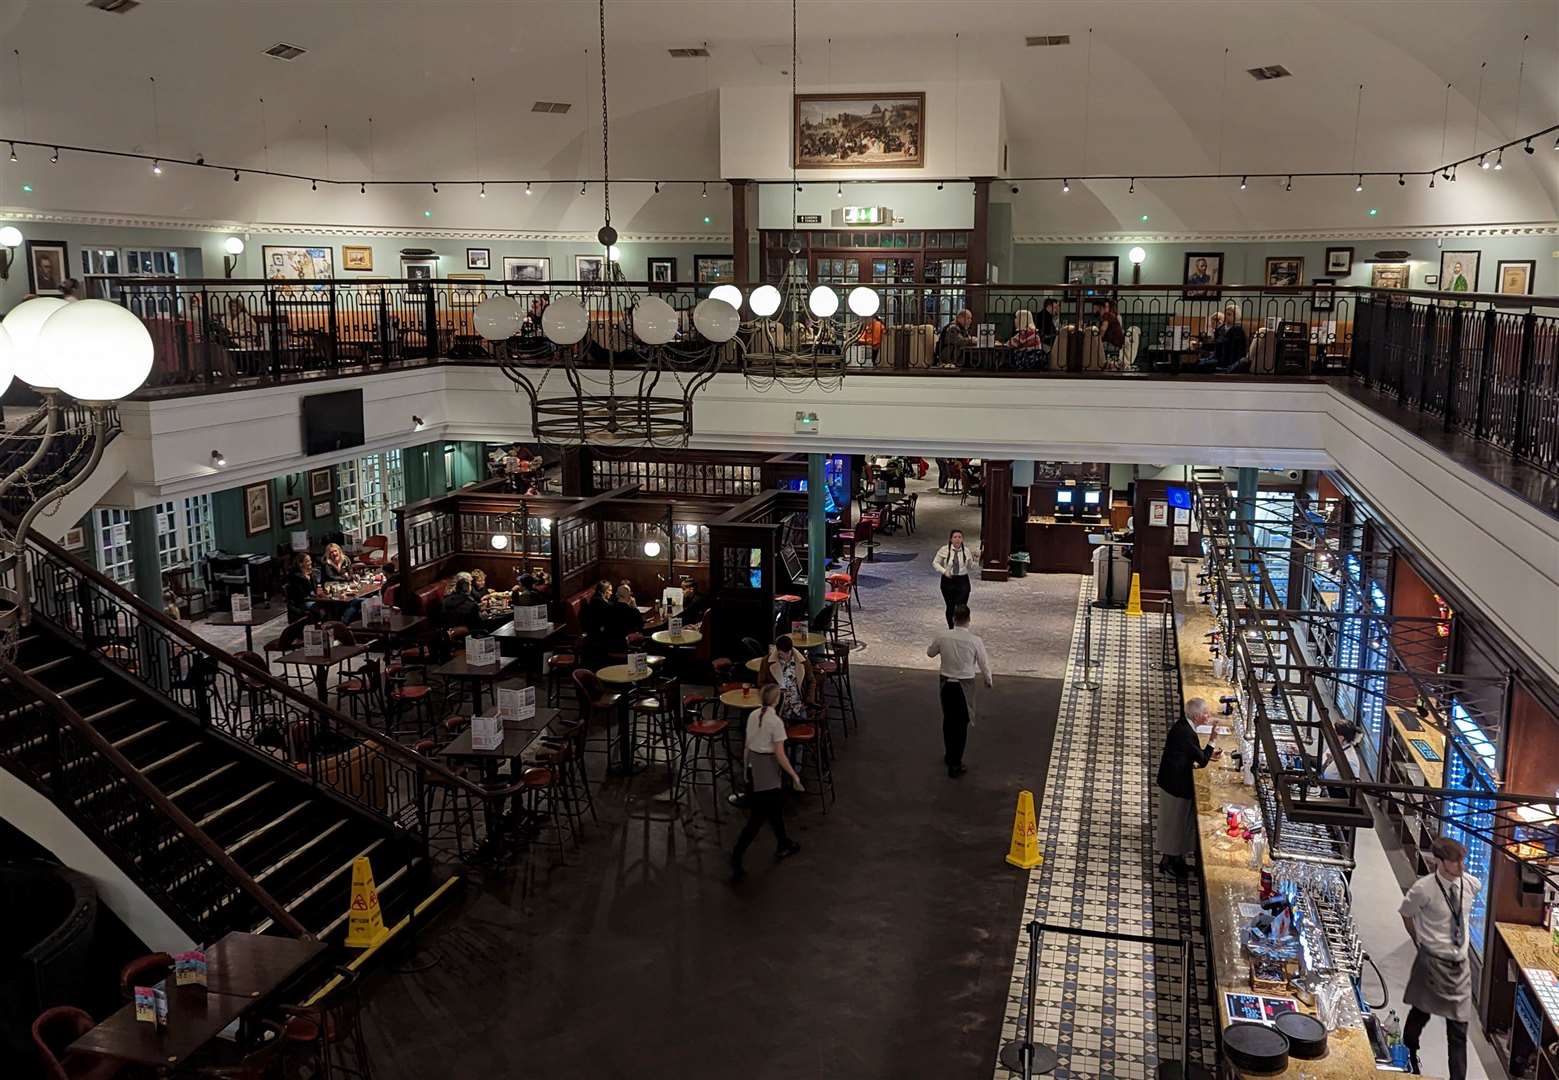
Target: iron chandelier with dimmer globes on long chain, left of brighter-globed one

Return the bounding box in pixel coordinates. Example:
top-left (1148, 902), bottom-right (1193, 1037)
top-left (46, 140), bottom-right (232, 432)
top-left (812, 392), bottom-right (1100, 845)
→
top-left (474, 0), bottom-right (741, 446)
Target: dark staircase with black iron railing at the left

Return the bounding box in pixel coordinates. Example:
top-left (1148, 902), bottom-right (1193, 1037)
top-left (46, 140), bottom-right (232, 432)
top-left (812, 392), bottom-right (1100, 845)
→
top-left (0, 526), bottom-right (483, 943)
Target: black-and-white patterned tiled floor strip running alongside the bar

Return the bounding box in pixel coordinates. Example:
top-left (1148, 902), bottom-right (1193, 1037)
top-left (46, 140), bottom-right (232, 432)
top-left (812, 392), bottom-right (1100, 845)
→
top-left (995, 581), bottom-right (1216, 1080)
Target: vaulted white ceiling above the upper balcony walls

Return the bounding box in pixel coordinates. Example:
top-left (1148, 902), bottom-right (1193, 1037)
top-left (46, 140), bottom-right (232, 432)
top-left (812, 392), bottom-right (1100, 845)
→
top-left (0, 0), bottom-right (1559, 235)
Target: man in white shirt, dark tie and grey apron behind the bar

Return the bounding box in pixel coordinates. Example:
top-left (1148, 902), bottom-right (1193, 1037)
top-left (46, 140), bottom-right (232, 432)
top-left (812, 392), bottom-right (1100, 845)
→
top-left (1397, 837), bottom-right (1483, 1080)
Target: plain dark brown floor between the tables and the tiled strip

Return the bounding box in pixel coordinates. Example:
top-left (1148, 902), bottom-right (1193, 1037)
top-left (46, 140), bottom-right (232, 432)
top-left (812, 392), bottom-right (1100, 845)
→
top-left (365, 665), bottom-right (1062, 1080)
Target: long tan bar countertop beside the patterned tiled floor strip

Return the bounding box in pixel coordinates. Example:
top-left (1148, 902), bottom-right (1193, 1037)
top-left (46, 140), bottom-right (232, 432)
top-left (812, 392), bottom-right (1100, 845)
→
top-left (1174, 585), bottom-right (1428, 1080)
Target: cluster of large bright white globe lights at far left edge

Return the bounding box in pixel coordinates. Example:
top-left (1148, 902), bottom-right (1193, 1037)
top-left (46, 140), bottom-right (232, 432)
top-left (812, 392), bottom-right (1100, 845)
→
top-left (0, 296), bottom-right (153, 405)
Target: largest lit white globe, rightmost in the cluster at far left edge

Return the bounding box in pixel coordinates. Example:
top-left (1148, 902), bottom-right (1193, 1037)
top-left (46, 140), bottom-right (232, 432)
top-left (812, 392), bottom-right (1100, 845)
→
top-left (37, 301), bottom-right (154, 402)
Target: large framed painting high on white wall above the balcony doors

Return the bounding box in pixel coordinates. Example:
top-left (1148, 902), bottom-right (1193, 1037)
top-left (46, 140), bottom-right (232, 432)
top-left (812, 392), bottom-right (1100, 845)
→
top-left (792, 92), bottom-right (926, 168)
